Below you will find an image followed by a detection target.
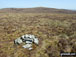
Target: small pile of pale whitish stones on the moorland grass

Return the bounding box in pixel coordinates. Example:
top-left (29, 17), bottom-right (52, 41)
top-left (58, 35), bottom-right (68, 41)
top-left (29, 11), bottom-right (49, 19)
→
top-left (14, 34), bottom-right (39, 50)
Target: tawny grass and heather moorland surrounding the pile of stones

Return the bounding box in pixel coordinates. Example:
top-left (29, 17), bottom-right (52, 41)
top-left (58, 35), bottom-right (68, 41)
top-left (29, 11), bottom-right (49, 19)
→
top-left (0, 13), bottom-right (76, 57)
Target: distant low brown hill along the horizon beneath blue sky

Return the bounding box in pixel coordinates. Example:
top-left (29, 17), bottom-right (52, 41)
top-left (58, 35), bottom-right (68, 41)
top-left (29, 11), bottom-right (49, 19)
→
top-left (0, 7), bottom-right (76, 14)
